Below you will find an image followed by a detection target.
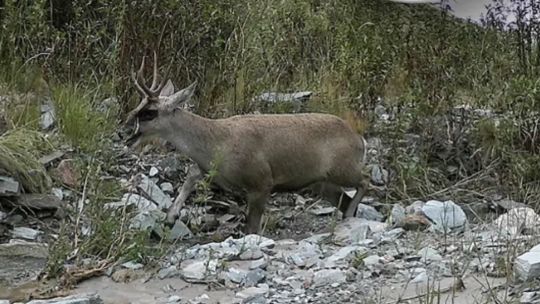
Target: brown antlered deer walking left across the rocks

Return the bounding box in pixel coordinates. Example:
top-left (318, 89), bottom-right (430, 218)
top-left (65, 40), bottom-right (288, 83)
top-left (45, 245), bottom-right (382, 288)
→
top-left (124, 52), bottom-right (366, 234)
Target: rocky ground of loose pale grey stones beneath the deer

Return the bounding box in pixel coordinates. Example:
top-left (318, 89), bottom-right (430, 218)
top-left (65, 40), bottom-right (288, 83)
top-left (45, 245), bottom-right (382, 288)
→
top-left (0, 96), bottom-right (540, 304)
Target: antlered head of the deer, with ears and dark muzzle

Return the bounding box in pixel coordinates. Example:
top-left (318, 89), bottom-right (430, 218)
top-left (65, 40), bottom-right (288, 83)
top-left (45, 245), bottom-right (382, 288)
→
top-left (124, 53), bottom-right (197, 147)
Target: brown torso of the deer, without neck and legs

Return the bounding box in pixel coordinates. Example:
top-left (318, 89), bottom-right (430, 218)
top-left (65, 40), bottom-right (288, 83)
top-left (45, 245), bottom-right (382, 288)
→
top-left (214, 114), bottom-right (363, 189)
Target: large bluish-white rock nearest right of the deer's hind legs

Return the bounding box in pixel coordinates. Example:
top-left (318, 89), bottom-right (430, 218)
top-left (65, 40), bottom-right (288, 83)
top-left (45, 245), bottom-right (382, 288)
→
top-left (422, 200), bottom-right (467, 232)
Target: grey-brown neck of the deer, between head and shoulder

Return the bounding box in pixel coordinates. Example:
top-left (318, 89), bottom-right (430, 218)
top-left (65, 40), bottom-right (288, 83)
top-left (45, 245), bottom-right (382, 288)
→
top-left (164, 110), bottom-right (227, 171)
